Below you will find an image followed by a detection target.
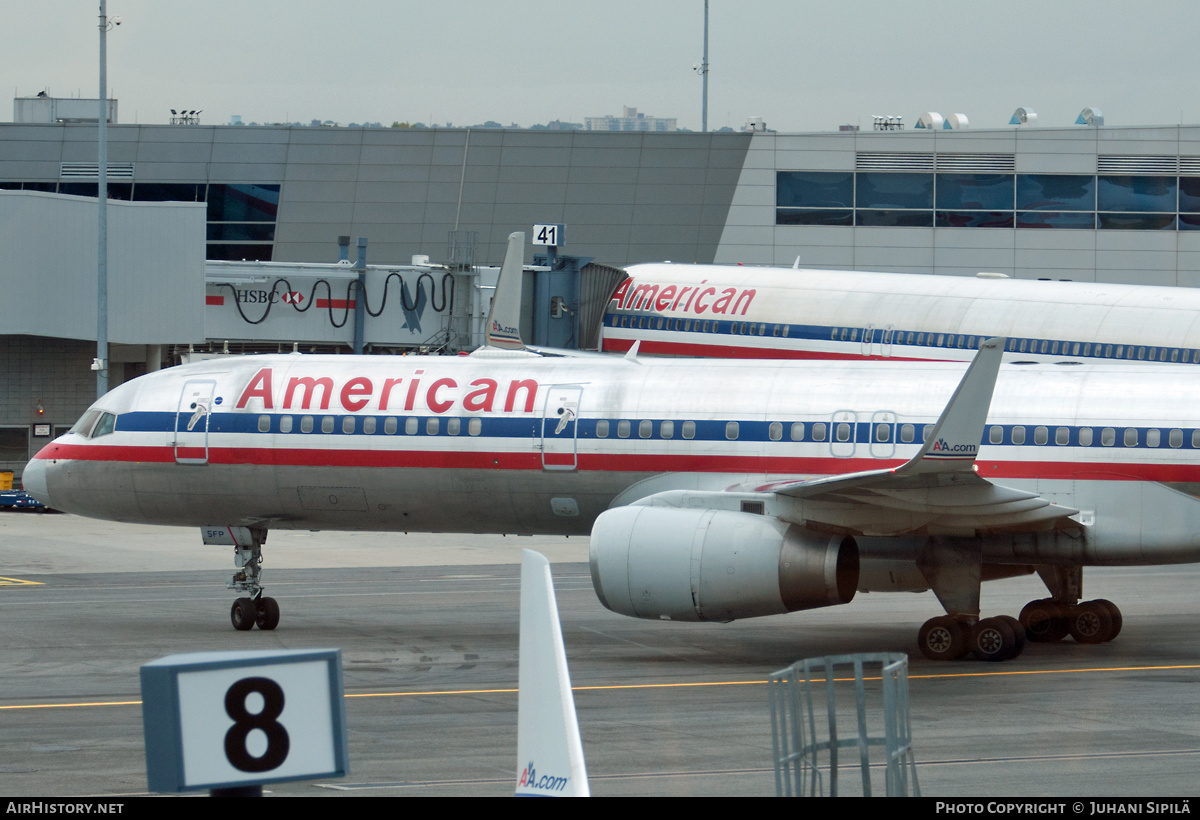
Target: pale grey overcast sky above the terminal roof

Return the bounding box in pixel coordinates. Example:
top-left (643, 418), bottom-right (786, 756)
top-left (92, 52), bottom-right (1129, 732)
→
top-left (0, 0), bottom-right (1200, 131)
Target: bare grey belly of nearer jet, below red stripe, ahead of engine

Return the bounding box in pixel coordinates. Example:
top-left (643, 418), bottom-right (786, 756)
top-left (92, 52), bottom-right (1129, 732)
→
top-left (59, 462), bottom-right (644, 535)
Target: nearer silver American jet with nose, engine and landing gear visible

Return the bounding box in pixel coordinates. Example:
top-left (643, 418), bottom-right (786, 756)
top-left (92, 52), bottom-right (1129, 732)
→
top-left (24, 235), bottom-right (1200, 660)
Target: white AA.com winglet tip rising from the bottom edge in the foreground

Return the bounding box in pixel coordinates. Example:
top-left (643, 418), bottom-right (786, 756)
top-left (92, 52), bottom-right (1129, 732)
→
top-left (516, 550), bottom-right (590, 797)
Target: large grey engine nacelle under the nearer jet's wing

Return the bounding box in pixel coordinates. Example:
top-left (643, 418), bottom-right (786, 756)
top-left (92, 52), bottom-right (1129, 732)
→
top-left (590, 505), bottom-right (858, 622)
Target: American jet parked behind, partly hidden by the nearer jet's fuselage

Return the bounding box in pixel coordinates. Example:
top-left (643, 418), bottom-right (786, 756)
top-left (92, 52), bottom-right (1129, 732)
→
top-left (600, 263), bottom-right (1200, 364)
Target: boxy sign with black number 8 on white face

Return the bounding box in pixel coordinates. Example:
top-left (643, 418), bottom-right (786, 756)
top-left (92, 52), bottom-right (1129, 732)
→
top-left (142, 650), bottom-right (349, 791)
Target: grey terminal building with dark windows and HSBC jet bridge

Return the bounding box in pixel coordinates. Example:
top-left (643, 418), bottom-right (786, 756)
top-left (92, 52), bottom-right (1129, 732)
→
top-left (0, 116), bottom-right (1200, 472)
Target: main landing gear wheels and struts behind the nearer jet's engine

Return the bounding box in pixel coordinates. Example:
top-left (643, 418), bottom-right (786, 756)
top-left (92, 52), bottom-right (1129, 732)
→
top-left (917, 537), bottom-right (1122, 662)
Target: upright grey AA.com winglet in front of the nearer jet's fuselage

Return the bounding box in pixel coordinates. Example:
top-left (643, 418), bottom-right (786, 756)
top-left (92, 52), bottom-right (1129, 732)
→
top-left (896, 337), bottom-right (1007, 473)
